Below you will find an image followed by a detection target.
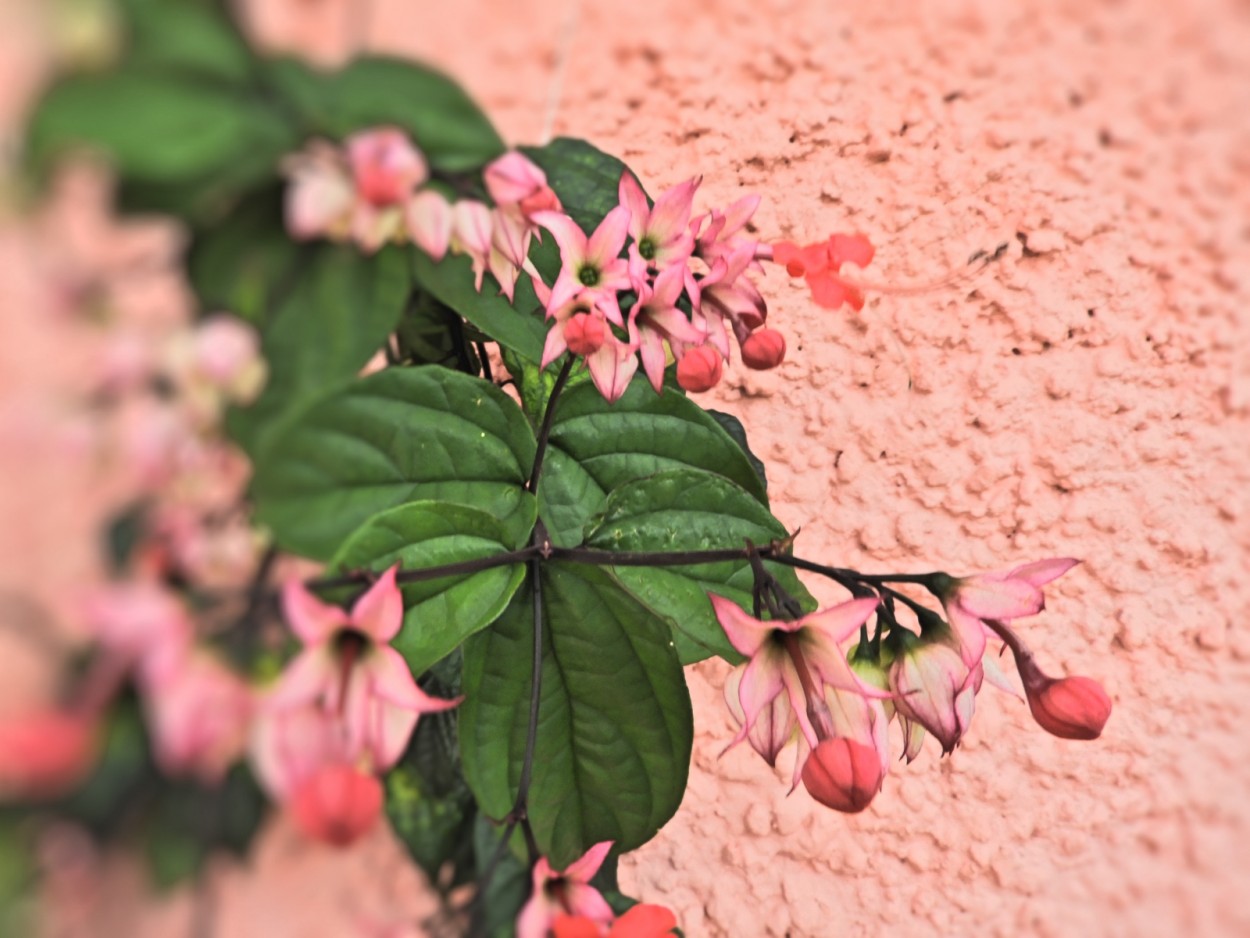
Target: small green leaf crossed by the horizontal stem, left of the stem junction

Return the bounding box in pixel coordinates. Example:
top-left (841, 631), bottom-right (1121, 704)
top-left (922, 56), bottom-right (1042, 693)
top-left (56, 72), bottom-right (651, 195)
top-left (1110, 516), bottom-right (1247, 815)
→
top-left (330, 502), bottom-right (538, 674)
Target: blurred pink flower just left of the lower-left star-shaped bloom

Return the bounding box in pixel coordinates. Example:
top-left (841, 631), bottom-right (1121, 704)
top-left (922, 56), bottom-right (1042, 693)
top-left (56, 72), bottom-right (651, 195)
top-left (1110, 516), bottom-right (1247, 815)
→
top-left (144, 652), bottom-right (253, 784)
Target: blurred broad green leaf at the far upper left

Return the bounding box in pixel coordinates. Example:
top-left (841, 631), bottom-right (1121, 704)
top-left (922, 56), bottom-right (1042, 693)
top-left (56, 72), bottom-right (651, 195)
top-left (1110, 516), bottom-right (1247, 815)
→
top-left (28, 70), bottom-right (286, 186)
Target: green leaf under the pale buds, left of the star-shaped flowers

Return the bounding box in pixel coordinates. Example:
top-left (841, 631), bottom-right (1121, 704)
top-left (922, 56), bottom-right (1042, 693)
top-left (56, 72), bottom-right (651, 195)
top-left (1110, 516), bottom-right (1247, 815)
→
top-left (413, 250), bottom-right (546, 361)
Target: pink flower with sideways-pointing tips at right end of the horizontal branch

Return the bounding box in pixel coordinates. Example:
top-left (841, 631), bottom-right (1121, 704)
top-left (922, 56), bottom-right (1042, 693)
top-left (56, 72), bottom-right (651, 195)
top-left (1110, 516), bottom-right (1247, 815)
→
top-left (935, 557), bottom-right (1080, 667)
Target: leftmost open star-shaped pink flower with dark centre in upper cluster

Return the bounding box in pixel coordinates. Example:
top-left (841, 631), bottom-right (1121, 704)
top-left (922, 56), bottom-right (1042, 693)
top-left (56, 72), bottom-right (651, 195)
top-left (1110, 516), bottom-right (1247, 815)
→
top-left (534, 205), bottom-right (631, 326)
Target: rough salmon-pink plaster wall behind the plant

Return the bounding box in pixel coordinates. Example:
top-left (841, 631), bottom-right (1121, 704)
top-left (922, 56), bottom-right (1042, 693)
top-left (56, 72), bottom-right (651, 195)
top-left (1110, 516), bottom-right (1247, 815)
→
top-left (0, 0), bottom-right (1250, 938)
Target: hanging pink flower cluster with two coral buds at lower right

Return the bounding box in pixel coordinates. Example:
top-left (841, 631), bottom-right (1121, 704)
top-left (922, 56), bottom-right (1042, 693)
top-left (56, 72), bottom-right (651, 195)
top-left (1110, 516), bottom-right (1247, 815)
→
top-left (710, 558), bottom-right (1111, 813)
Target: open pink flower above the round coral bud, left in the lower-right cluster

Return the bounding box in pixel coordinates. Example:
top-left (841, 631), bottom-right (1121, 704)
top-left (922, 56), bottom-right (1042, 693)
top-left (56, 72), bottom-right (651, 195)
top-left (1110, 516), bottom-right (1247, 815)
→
top-left (710, 594), bottom-right (889, 765)
